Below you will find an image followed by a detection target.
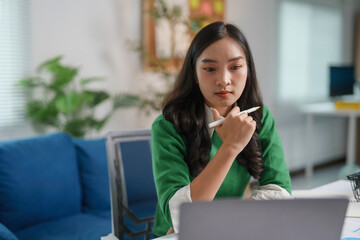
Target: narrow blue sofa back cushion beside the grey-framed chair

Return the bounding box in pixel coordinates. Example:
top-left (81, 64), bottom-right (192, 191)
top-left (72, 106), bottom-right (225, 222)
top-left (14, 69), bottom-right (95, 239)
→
top-left (74, 139), bottom-right (110, 212)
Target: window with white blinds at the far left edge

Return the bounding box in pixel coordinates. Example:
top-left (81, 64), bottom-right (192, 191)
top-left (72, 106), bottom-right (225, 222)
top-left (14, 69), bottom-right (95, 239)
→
top-left (0, 0), bottom-right (31, 134)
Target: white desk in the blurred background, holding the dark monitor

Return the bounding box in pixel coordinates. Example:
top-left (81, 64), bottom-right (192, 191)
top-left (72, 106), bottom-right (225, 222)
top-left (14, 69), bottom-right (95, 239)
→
top-left (301, 102), bottom-right (360, 178)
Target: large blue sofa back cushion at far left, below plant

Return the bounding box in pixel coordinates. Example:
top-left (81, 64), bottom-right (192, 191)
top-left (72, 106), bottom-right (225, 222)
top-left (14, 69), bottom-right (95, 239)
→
top-left (0, 133), bottom-right (81, 231)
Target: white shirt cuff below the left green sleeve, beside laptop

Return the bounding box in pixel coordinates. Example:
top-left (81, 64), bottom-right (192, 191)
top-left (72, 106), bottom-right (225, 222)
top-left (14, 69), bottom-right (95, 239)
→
top-left (169, 184), bottom-right (192, 233)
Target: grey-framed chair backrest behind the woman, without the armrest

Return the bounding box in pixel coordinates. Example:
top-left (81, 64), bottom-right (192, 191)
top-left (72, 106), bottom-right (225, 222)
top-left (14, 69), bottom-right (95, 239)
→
top-left (106, 129), bottom-right (157, 239)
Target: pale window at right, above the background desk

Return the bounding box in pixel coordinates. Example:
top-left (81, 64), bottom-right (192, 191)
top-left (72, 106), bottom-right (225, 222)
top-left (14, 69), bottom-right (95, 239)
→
top-left (278, 0), bottom-right (343, 103)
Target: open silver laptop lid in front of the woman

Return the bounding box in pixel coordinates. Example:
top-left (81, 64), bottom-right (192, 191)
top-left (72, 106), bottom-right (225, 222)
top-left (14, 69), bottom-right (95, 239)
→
top-left (178, 198), bottom-right (348, 240)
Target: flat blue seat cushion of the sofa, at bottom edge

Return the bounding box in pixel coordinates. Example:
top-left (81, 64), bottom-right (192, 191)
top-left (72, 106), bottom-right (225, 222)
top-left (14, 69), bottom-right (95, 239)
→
top-left (15, 213), bottom-right (111, 240)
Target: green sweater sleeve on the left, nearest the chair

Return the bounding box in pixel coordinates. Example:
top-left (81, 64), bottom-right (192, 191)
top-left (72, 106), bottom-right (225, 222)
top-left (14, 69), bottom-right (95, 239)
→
top-left (151, 115), bottom-right (191, 226)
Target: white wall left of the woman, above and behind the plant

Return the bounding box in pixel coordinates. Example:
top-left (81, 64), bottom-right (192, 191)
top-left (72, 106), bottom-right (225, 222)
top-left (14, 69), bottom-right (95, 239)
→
top-left (32, 0), bottom-right (150, 136)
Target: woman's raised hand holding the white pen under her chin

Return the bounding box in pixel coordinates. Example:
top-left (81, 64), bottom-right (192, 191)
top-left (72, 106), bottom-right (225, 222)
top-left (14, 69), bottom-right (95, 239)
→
top-left (212, 106), bottom-right (256, 154)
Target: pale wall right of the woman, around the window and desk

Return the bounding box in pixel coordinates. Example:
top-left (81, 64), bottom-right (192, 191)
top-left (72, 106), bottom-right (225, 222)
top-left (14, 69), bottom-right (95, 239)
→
top-left (227, 0), bottom-right (360, 169)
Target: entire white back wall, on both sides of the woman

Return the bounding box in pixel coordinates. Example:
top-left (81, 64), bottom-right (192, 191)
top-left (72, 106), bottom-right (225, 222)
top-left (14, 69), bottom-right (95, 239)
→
top-left (32, 0), bottom-right (360, 169)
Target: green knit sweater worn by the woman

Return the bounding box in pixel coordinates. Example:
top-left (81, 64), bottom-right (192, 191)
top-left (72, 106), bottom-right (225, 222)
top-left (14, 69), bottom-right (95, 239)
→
top-left (151, 106), bottom-right (291, 236)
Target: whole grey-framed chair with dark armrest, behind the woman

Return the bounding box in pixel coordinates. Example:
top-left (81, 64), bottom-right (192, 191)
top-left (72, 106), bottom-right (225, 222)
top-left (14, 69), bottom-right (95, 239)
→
top-left (106, 130), bottom-right (157, 240)
